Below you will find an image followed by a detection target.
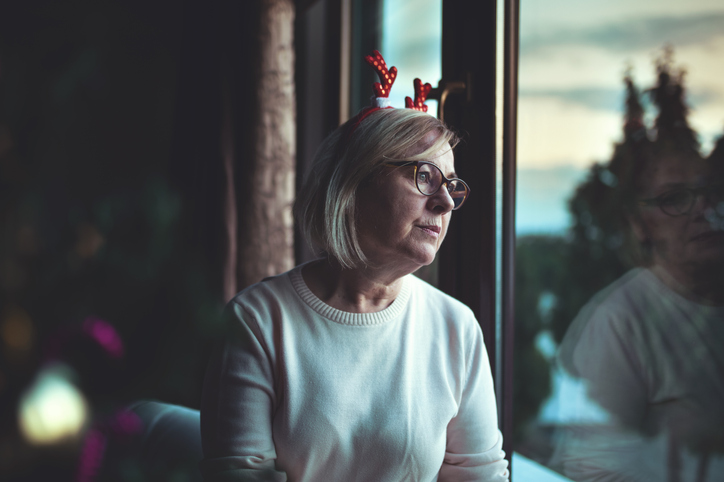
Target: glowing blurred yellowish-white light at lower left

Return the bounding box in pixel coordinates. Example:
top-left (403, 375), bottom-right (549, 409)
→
top-left (18, 365), bottom-right (88, 445)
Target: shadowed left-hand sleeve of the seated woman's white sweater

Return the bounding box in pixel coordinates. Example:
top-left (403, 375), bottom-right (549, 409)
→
top-left (200, 302), bottom-right (287, 482)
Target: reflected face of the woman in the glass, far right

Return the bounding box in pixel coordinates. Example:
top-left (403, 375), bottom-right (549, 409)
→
top-left (632, 157), bottom-right (724, 272)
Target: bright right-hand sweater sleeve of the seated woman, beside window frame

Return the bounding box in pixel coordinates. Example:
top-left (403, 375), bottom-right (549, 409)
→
top-left (439, 323), bottom-right (508, 482)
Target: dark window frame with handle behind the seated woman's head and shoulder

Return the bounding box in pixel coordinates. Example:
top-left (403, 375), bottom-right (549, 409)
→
top-left (295, 0), bottom-right (520, 470)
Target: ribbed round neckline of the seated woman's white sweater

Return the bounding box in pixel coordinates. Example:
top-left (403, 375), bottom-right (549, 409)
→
top-left (289, 264), bottom-right (411, 326)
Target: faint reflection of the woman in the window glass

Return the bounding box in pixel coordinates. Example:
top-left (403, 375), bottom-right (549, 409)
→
top-left (560, 149), bottom-right (724, 481)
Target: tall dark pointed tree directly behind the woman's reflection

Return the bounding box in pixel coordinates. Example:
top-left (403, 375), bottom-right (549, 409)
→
top-left (552, 50), bottom-right (699, 341)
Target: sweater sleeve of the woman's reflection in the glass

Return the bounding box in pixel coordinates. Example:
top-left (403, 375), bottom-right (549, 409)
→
top-left (559, 310), bottom-right (656, 482)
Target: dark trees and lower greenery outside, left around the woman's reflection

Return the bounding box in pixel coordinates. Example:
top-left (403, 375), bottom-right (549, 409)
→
top-left (515, 50), bottom-right (724, 457)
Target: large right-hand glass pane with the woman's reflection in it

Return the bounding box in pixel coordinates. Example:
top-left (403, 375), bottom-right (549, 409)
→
top-left (513, 0), bottom-right (724, 481)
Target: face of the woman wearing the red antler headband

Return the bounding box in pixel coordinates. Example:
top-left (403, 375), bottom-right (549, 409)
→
top-left (357, 141), bottom-right (457, 273)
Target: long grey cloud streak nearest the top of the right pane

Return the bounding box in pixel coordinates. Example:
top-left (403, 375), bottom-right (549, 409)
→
top-left (520, 12), bottom-right (724, 56)
